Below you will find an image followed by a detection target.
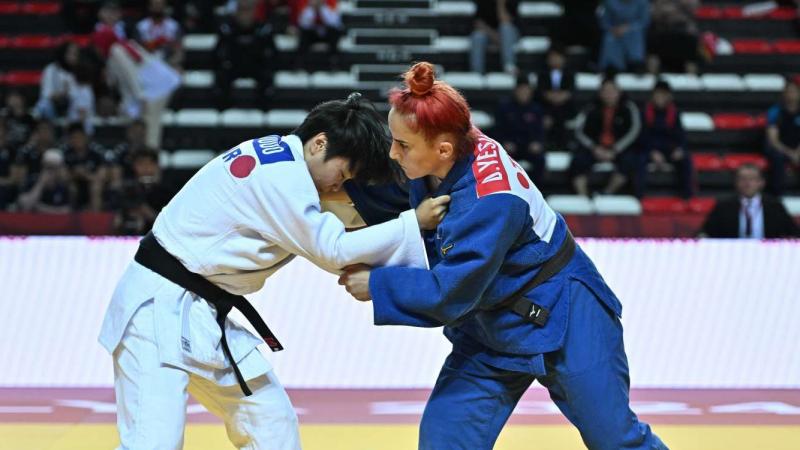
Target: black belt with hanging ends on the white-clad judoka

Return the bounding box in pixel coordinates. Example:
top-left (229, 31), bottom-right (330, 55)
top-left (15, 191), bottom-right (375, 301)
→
top-left (133, 232), bottom-right (283, 395)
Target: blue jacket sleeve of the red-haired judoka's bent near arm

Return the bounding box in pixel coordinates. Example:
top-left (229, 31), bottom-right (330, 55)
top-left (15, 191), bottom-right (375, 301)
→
top-left (369, 193), bottom-right (530, 327)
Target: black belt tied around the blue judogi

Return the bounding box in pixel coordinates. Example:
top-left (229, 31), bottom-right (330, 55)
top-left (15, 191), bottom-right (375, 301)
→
top-left (491, 231), bottom-right (575, 327)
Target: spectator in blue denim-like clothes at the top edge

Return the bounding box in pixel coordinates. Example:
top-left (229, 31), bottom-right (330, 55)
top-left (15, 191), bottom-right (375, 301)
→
top-left (599, 0), bottom-right (650, 72)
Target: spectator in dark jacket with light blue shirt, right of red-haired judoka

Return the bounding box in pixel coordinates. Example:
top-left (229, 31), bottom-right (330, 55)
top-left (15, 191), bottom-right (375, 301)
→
top-left (536, 44), bottom-right (575, 150)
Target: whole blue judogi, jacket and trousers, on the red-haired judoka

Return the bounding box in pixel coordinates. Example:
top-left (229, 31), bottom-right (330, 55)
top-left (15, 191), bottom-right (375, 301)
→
top-left (356, 132), bottom-right (666, 450)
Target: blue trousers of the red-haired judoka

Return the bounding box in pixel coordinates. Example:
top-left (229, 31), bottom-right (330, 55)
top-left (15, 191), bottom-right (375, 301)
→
top-left (419, 281), bottom-right (667, 450)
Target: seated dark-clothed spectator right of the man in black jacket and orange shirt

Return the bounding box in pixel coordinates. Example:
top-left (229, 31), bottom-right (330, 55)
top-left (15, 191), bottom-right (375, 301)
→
top-left (635, 81), bottom-right (694, 198)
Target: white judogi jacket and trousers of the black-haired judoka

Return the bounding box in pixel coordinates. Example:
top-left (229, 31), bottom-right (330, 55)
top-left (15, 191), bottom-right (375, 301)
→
top-left (99, 135), bottom-right (427, 450)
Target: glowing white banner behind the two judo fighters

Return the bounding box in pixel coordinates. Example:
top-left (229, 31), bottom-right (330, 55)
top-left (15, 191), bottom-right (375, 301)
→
top-left (0, 237), bottom-right (800, 389)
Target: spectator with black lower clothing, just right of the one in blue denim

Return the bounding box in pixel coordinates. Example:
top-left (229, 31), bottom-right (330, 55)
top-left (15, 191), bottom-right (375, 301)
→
top-left (647, 0), bottom-right (700, 73)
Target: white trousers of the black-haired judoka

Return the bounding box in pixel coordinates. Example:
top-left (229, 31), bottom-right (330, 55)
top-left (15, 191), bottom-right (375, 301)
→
top-left (101, 262), bottom-right (301, 450)
